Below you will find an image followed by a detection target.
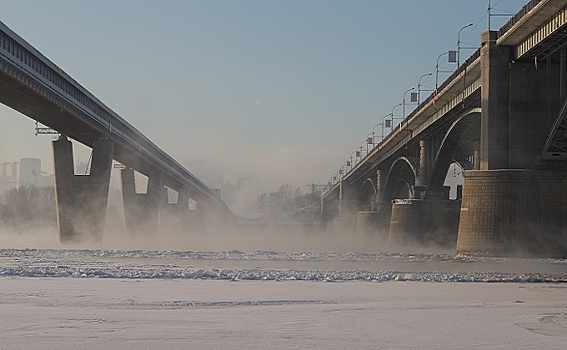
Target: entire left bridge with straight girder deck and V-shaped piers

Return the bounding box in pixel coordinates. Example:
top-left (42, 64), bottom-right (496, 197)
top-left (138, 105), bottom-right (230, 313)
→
top-left (0, 22), bottom-right (232, 242)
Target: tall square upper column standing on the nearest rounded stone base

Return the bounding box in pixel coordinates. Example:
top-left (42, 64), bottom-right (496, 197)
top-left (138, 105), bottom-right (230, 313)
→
top-left (479, 32), bottom-right (562, 170)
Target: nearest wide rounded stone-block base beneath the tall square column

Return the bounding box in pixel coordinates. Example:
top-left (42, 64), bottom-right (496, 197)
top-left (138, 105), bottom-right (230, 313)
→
top-left (457, 170), bottom-right (567, 257)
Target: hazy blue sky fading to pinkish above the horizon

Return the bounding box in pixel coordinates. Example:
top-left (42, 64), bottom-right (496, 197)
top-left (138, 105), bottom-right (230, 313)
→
top-left (0, 0), bottom-right (527, 190)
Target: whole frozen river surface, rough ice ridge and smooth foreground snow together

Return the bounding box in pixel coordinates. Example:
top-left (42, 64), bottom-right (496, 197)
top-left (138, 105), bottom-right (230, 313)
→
top-left (0, 249), bottom-right (567, 350)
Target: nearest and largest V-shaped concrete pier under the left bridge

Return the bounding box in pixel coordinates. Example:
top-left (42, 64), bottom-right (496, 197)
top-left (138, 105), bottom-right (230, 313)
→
top-left (52, 136), bottom-right (114, 243)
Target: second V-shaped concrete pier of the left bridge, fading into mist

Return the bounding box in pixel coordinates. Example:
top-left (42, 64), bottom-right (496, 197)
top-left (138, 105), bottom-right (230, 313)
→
top-left (120, 168), bottom-right (166, 235)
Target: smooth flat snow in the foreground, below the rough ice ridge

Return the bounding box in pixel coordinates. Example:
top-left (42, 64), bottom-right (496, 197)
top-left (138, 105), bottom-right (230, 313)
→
top-left (0, 277), bottom-right (567, 350)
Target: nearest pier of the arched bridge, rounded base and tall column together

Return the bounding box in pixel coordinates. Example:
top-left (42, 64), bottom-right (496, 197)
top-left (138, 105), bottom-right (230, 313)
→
top-left (457, 32), bottom-right (567, 257)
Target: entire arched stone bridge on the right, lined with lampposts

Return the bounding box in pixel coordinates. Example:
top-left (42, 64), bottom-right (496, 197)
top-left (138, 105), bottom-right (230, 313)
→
top-left (322, 0), bottom-right (567, 257)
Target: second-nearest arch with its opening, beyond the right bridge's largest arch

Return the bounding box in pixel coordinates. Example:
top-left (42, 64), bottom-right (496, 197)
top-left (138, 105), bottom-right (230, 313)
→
top-left (382, 157), bottom-right (417, 202)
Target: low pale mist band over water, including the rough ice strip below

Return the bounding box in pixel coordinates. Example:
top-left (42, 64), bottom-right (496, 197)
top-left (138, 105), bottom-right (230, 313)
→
top-left (0, 220), bottom-right (567, 283)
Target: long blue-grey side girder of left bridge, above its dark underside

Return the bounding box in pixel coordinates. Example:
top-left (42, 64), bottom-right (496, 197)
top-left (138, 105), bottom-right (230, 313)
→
top-left (0, 22), bottom-right (215, 199)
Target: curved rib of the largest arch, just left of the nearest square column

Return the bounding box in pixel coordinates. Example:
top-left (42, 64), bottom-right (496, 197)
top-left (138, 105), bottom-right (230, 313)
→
top-left (426, 108), bottom-right (480, 196)
